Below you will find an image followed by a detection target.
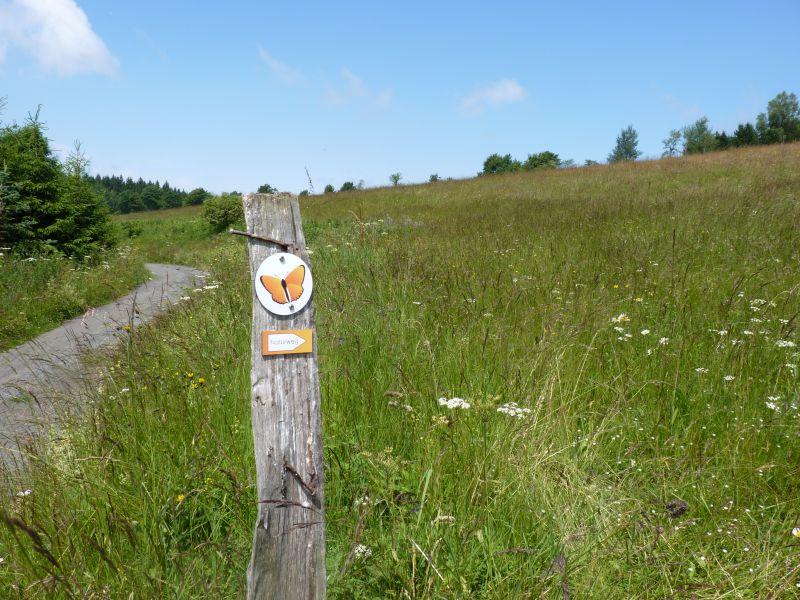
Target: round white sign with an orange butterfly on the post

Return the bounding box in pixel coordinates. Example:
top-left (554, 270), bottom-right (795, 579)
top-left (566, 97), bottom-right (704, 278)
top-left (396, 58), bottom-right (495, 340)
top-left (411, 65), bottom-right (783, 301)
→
top-left (255, 252), bottom-right (314, 316)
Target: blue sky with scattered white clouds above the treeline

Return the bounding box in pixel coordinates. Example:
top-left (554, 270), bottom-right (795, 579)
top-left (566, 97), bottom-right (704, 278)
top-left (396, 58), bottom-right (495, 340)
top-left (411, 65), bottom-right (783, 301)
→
top-left (0, 0), bottom-right (800, 192)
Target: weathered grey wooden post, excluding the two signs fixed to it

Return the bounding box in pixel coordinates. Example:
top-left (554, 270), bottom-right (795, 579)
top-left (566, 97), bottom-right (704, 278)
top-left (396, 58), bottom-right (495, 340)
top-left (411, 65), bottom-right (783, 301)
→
top-left (244, 194), bottom-right (326, 600)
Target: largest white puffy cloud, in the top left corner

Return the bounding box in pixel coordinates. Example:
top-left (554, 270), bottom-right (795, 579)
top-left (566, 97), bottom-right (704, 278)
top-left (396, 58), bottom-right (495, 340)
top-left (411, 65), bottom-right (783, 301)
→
top-left (0, 0), bottom-right (119, 77)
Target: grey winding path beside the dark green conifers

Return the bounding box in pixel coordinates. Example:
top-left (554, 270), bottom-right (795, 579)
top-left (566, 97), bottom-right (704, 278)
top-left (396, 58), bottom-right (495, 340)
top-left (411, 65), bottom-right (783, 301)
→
top-left (0, 264), bottom-right (206, 467)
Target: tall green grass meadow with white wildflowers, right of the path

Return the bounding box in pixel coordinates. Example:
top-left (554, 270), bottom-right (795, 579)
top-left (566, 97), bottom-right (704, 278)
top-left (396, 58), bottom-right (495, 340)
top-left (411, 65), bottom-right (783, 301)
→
top-left (0, 144), bottom-right (800, 599)
